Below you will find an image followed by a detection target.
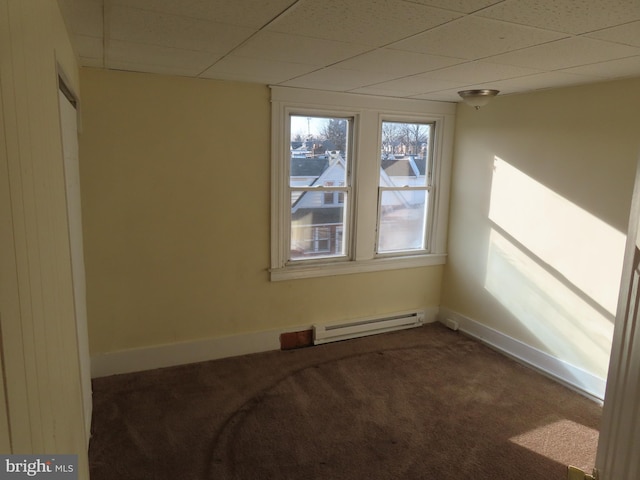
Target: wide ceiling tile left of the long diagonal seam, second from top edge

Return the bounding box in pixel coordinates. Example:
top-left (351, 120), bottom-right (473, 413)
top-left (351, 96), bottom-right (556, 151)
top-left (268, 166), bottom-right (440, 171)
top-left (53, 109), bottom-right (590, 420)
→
top-left (108, 6), bottom-right (254, 53)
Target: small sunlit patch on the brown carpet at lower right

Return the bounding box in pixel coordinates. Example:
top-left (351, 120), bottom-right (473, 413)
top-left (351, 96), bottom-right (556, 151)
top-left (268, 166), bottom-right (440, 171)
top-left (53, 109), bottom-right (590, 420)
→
top-left (510, 419), bottom-right (598, 470)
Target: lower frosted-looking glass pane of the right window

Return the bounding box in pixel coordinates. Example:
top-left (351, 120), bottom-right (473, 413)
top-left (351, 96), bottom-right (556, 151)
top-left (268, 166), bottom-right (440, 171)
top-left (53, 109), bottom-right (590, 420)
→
top-left (378, 190), bottom-right (427, 253)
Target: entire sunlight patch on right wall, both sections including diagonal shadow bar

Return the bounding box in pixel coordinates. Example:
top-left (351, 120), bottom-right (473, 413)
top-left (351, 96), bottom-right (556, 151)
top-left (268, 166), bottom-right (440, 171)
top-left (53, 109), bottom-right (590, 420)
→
top-left (485, 157), bottom-right (625, 378)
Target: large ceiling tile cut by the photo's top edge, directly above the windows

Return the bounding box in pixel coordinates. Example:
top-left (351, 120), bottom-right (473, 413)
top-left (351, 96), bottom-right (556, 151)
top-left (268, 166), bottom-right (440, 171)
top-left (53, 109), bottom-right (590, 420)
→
top-left (267, 0), bottom-right (460, 47)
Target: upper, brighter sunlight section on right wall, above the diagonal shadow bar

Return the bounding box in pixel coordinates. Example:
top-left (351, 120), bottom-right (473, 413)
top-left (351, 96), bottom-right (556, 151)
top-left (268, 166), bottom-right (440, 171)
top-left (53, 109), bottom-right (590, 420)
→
top-left (489, 157), bottom-right (625, 315)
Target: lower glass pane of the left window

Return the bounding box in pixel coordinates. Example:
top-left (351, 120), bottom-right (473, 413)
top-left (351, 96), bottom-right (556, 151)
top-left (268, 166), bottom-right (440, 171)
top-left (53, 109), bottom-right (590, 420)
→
top-left (290, 190), bottom-right (348, 260)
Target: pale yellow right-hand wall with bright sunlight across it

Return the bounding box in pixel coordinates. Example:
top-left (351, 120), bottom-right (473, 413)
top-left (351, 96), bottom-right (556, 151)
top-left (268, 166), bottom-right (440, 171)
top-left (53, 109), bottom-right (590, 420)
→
top-left (442, 79), bottom-right (640, 378)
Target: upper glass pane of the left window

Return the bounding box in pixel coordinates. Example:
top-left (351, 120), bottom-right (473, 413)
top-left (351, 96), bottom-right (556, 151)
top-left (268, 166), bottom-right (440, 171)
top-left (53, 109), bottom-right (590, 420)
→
top-left (289, 115), bottom-right (349, 187)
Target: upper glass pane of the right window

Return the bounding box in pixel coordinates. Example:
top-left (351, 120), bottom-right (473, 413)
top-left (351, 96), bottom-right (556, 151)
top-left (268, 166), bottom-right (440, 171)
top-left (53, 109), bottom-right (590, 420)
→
top-left (380, 122), bottom-right (433, 187)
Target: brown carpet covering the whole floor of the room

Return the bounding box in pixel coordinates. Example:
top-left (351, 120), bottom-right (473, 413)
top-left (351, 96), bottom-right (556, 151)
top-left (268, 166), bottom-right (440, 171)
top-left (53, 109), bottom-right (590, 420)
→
top-left (90, 324), bottom-right (601, 480)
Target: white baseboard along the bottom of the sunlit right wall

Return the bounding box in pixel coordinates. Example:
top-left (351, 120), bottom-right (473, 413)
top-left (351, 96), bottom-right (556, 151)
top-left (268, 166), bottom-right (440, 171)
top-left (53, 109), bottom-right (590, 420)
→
top-left (439, 308), bottom-right (607, 402)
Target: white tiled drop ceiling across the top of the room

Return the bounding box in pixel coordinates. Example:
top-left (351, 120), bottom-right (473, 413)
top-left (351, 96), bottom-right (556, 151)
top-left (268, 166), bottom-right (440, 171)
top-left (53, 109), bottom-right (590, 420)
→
top-left (59, 0), bottom-right (640, 102)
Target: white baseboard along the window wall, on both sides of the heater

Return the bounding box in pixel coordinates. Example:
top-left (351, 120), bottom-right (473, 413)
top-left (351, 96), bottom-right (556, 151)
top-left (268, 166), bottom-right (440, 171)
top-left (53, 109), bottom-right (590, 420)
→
top-left (91, 307), bottom-right (439, 378)
